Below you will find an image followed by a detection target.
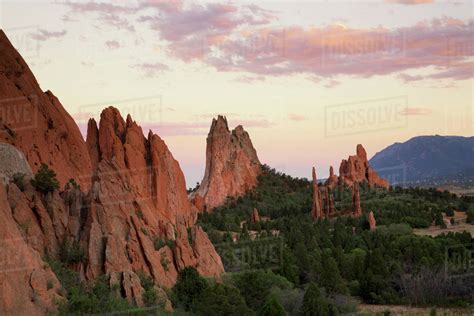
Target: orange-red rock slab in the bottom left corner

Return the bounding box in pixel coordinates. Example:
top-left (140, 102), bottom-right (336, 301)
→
top-left (0, 182), bottom-right (61, 315)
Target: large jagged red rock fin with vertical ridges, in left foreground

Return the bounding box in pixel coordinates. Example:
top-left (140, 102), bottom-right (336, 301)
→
top-left (86, 107), bottom-right (224, 287)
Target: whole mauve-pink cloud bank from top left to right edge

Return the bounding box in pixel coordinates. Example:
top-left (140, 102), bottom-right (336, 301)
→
top-left (57, 0), bottom-right (474, 82)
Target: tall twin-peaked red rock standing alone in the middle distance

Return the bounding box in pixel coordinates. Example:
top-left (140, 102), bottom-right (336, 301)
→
top-left (190, 116), bottom-right (262, 212)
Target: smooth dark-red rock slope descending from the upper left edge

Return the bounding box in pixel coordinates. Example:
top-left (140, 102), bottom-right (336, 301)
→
top-left (0, 30), bottom-right (91, 190)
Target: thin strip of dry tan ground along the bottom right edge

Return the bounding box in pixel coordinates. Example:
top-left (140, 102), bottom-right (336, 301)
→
top-left (359, 304), bottom-right (474, 316)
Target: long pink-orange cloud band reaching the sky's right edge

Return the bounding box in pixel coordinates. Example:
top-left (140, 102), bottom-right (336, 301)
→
top-left (196, 18), bottom-right (474, 79)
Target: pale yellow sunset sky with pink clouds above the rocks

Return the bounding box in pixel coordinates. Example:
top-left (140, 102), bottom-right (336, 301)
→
top-left (0, 0), bottom-right (474, 186)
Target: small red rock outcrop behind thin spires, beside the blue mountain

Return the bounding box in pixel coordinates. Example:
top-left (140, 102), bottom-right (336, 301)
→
top-left (326, 144), bottom-right (389, 189)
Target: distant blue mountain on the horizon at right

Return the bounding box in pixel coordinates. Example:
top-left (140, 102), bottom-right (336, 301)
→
top-left (369, 135), bottom-right (474, 185)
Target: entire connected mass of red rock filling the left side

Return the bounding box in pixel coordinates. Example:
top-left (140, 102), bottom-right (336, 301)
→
top-left (0, 33), bottom-right (224, 315)
